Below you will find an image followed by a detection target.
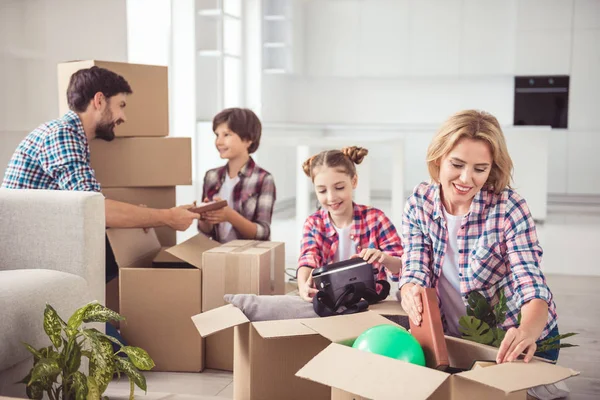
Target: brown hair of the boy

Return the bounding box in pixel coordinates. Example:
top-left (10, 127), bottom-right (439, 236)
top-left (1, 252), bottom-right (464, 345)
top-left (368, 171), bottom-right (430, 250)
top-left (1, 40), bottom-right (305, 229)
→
top-left (213, 108), bottom-right (262, 154)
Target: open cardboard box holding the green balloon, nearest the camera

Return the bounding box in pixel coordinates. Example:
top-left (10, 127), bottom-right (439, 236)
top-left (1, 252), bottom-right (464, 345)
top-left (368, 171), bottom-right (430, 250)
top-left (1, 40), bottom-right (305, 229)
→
top-left (297, 336), bottom-right (578, 400)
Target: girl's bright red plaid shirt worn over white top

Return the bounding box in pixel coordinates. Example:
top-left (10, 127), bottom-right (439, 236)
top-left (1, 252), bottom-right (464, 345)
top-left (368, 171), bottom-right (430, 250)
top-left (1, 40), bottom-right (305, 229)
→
top-left (298, 203), bottom-right (402, 281)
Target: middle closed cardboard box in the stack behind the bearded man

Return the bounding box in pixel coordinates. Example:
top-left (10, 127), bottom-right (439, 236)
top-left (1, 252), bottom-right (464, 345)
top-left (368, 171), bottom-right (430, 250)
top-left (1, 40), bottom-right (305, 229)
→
top-left (90, 137), bottom-right (192, 188)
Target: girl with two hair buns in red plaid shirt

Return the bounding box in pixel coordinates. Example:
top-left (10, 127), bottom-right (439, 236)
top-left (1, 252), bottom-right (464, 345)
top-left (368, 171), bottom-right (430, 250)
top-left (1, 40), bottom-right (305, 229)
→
top-left (297, 147), bottom-right (402, 301)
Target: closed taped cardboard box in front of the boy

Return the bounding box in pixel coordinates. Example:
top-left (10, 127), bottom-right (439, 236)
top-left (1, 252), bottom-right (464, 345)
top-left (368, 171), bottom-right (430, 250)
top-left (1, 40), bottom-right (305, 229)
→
top-left (202, 240), bottom-right (285, 371)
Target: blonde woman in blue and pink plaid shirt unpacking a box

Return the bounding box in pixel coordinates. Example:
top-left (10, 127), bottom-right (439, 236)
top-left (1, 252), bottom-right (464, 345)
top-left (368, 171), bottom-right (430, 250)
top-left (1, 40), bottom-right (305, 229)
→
top-left (400, 110), bottom-right (558, 363)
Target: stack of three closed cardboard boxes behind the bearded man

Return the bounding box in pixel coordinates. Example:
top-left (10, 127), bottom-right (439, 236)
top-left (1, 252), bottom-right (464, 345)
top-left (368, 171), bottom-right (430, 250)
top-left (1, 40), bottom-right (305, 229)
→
top-left (58, 60), bottom-right (192, 330)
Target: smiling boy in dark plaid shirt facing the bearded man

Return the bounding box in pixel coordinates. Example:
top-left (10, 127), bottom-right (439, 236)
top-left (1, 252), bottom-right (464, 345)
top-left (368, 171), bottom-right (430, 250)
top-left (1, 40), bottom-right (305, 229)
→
top-left (198, 108), bottom-right (275, 243)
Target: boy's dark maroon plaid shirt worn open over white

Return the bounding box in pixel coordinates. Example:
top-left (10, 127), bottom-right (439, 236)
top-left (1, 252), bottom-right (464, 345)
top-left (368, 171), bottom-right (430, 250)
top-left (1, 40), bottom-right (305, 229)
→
top-left (202, 157), bottom-right (276, 241)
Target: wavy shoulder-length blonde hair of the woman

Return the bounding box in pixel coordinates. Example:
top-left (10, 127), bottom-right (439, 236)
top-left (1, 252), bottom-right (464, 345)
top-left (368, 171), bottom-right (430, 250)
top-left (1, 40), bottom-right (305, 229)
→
top-left (427, 110), bottom-right (513, 193)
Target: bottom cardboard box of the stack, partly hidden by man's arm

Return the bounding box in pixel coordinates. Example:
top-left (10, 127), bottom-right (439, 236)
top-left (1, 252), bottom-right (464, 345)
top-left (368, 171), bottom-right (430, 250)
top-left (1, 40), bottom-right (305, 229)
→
top-left (102, 186), bottom-right (177, 247)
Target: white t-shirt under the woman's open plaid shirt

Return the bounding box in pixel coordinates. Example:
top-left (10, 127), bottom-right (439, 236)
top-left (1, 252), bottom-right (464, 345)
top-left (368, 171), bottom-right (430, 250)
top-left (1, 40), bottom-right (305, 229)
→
top-left (438, 207), bottom-right (467, 337)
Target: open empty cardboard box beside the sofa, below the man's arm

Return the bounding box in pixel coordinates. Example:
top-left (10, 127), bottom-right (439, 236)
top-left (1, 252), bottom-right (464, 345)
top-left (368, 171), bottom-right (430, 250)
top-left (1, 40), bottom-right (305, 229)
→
top-left (107, 229), bottom-right (219, 372)
